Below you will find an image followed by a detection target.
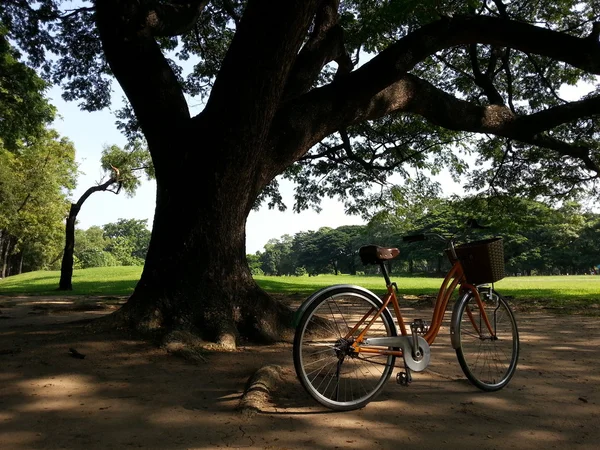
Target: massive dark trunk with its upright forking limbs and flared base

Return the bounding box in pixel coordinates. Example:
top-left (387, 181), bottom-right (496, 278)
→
top-left (95, 0), bottom-right (318, 348)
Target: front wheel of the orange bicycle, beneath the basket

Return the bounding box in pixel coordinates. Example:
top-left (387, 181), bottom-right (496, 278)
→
top-left (454, 289), bottom-right (519, 392)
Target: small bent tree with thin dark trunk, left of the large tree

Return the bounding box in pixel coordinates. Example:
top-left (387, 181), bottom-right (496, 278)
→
top-left (58, 141), bottom-right (154, 291)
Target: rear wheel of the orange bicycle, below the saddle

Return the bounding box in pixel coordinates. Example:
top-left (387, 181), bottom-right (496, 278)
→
top-left (294, 286), bottom-right (396, 411)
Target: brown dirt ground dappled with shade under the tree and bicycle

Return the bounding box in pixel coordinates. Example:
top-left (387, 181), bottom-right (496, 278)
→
top-left (0, 297), bottom-right (600, 450)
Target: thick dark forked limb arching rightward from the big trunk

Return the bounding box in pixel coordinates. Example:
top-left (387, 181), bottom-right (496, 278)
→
top-left (274, 17), bottom-right (600, 171)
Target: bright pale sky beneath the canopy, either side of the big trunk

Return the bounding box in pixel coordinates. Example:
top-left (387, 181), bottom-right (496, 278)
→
top-left (48, 87), bottom-right (365, 253)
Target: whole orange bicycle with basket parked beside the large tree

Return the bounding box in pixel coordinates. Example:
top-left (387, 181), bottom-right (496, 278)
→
top-left (293, 221), bottom-right (519, 411)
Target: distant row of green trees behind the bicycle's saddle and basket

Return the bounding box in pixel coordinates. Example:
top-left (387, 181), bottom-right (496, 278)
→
top-left (247, 198), bottom-right (600, 275)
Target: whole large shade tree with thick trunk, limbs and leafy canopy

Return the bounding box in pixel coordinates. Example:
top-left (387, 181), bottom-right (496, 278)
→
top-left (0, 0), bottom-right (600, 346)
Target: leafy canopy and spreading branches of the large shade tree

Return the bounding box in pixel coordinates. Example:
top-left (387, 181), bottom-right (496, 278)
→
top-left (0, 0), bottom-right (600, 213)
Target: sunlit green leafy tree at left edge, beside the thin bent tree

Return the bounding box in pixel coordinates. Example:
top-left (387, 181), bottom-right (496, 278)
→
top-left (0, 130), bottom-right (77, 277)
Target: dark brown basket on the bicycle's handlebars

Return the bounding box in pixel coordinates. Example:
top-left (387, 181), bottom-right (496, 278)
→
top-left (455, 238), bottom-right (505, 284)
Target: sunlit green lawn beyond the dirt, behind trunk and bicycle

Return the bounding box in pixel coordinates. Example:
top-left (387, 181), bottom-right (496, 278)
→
top-left (0, 267), bottom-right (600, 308)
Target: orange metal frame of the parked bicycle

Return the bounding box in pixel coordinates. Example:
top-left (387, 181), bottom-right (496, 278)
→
top-left (345, 259), bottom-right (494, 356)
